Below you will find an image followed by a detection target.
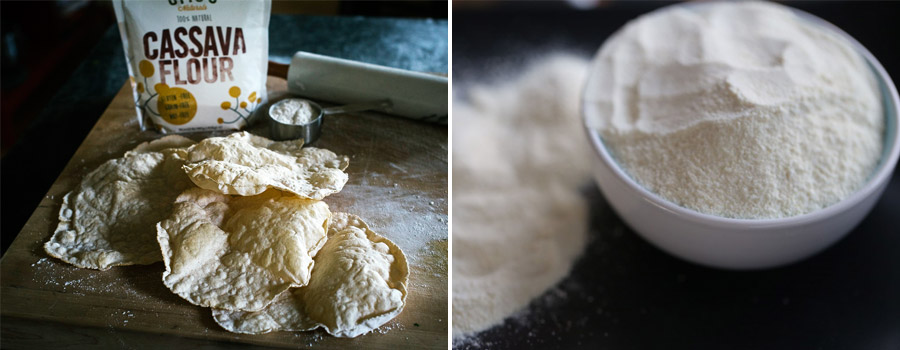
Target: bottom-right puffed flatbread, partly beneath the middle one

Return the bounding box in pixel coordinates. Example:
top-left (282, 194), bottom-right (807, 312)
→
top-left (213, 213), bottom-right (409, 337)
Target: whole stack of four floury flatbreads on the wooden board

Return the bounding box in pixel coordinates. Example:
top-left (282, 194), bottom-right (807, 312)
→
top-left (44, 132), bottom-right (409, 337)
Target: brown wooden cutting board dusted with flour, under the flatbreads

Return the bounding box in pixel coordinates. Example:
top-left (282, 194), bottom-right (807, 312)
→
top-left (0, 77), bottom-right (448, 350)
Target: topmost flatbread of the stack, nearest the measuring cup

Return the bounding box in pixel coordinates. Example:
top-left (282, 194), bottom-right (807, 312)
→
top-left (184, 132), bottom-right (349, 200)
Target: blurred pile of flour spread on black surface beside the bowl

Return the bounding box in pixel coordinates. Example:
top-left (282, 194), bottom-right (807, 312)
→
top-left (452, 55), bottom-right (592, 339)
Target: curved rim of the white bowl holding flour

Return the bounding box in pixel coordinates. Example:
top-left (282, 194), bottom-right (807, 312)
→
top-left (580, 3), bottom-right (900, 234)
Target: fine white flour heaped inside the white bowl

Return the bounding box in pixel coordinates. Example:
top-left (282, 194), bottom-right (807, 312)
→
top-left (585, 2), bottom-right (884, 219)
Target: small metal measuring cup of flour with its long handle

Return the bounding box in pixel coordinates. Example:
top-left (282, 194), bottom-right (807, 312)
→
top-left (268, 98), bottom-right (393, 146)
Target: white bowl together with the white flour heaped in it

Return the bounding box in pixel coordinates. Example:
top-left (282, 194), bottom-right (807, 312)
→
top-left (582, 2), bottom-right (900, 269)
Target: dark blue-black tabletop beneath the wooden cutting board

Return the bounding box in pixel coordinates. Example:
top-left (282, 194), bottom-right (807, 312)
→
top-left (0, 15), bottom-right (448, 252)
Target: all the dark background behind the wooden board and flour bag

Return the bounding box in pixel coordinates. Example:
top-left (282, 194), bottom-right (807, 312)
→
top-left (0, 0), bottom-right (448, 252)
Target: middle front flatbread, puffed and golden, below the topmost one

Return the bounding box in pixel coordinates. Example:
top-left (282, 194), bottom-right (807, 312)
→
top-left (156, 188), bottom-right (331, 311)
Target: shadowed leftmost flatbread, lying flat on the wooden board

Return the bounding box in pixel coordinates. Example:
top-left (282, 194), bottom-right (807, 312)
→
top-left (44, 135), bottom-right (194, 270)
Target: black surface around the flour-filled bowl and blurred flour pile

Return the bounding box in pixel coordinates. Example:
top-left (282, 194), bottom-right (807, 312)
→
top-left (452, 2), bottom-right (900, 350)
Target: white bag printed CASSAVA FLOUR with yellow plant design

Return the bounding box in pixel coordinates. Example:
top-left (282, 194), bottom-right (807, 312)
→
top-left (113, 0), bottom-right (271, 133)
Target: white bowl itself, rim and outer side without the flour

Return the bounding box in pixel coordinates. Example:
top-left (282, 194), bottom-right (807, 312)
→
top-left (582, 5), bottom-right (900, 269)
